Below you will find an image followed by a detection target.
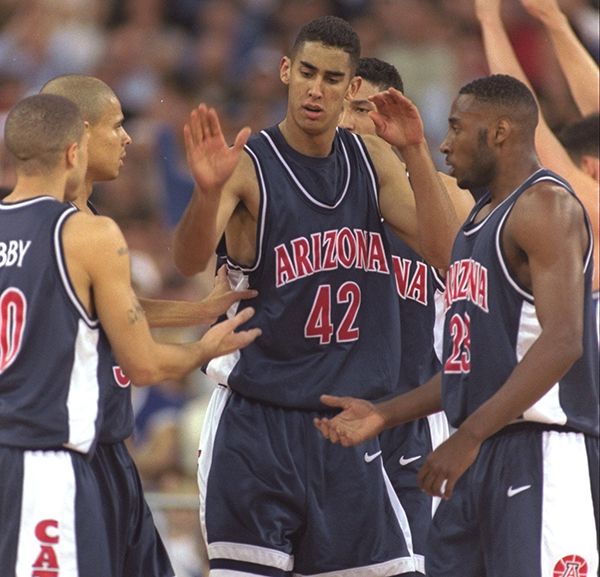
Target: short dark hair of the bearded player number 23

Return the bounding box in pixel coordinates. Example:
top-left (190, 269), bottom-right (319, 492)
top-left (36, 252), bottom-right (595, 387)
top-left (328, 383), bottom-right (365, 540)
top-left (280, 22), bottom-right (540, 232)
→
top-left (459, 74), bottom-right (539, 130)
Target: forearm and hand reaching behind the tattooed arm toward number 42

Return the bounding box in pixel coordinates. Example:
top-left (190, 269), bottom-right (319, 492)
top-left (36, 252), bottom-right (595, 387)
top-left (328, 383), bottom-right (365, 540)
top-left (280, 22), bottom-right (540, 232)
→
top-left (139, 265), bottom-right (258, 329)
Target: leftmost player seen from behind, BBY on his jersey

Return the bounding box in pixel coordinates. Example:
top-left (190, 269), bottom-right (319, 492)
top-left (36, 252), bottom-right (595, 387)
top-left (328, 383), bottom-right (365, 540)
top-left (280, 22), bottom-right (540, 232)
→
top-left (0, 94), bottom-right (260, 577)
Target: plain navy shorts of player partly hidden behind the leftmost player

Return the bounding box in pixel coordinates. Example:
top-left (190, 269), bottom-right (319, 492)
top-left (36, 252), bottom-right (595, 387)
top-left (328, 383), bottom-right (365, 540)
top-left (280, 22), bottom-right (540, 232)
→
top-left (91, 442), bottom-right (175, 577)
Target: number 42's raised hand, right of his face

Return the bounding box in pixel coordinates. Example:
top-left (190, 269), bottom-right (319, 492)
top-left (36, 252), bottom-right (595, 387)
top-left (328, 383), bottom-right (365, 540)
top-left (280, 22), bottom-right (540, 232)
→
top-left (369, 88), bottom-right (425, 148)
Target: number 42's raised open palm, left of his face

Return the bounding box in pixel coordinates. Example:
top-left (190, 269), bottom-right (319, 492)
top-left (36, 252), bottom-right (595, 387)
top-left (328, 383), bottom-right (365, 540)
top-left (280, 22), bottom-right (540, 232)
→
top-left (183, 103), bottom-right (250, 198)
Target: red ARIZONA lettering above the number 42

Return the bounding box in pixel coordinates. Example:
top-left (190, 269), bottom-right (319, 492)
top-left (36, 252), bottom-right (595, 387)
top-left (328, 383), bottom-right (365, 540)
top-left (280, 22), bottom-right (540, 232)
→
top-left (275, 227), bottom-right (390, 288)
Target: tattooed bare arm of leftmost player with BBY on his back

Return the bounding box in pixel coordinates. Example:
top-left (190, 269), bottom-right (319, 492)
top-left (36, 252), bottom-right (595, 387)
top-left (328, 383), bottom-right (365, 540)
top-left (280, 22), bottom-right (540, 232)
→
top-left (63, 213), bottom-right (260, 385)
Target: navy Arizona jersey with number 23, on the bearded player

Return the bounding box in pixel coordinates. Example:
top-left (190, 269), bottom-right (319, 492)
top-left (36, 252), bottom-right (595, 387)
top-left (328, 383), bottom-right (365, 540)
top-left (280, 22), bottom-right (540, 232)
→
top-left (442, 169), bottom-right (598, 435)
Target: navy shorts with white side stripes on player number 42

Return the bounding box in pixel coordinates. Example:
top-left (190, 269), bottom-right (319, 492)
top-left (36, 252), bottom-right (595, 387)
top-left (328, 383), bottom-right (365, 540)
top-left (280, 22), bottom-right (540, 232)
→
top-left (198, 386), bottom-right (415, 577)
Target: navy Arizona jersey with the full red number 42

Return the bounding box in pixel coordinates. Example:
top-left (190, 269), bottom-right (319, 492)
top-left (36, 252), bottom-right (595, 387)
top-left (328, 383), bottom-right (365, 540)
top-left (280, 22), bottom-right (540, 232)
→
top-left (207, 127), bottom-right (400, 410)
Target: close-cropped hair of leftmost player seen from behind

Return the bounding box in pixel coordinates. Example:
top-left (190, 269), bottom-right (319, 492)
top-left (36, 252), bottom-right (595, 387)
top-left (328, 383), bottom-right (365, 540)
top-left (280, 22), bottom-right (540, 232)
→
top-left (4, 94), bottom-right (85, 175)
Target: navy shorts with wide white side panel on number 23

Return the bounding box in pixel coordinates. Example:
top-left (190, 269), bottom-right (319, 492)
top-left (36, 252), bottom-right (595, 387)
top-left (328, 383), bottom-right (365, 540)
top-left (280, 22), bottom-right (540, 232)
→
top-left (426, 423), bottom-right (599, 577)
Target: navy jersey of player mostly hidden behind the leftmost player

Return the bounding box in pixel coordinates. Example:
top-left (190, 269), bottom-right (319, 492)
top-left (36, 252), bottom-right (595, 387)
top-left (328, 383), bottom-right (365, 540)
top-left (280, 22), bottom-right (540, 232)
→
top-left (87, 201), bottom-right (134, 443)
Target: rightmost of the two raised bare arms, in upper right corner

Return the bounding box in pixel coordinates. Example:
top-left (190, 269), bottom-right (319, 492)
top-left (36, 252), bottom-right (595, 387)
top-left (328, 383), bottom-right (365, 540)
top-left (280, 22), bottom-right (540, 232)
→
top-left (521, 0), bottom-right (600, 116)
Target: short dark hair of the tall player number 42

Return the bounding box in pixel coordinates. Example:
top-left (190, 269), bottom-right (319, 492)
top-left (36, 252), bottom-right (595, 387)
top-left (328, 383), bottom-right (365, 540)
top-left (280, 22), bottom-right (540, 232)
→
top-left (292, 16), bottom-right (360, 70)
